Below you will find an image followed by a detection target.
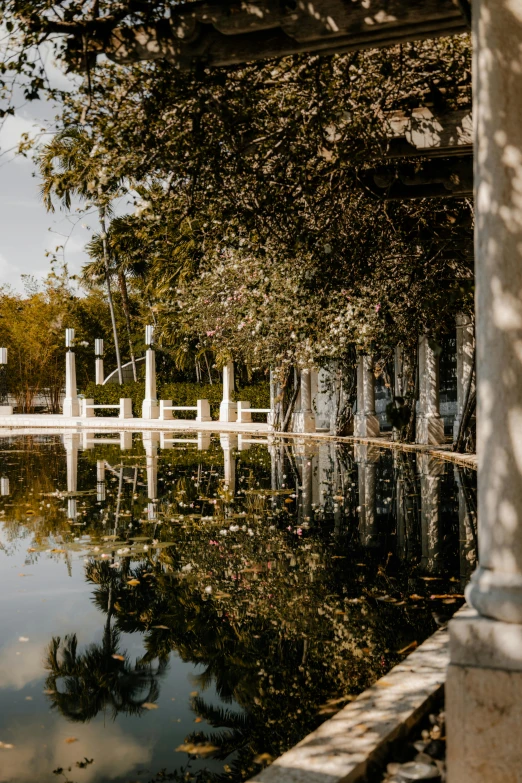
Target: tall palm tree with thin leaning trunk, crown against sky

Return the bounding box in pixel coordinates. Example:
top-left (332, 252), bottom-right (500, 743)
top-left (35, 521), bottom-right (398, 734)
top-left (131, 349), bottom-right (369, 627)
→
top-left (39, 127), bottom-right (123, 384)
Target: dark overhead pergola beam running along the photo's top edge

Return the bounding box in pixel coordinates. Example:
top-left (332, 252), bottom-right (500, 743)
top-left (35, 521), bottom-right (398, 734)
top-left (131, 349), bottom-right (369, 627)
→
top-left (69, 0), bottom-right (468, 68)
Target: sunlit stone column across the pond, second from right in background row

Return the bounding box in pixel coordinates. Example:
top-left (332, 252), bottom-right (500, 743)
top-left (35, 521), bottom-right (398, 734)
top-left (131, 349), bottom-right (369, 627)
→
top-left (415, 335), bottom-right (444, 446)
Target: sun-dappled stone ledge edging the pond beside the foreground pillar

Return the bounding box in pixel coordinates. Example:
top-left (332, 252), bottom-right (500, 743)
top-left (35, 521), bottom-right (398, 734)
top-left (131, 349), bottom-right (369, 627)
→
top-left (252, 630), bottom-right (449, 783)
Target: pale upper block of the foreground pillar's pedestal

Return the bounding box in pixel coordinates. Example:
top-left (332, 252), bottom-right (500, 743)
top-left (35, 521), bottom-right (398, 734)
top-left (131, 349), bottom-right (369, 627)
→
top-left (449, 607), bottom-right (522, 671)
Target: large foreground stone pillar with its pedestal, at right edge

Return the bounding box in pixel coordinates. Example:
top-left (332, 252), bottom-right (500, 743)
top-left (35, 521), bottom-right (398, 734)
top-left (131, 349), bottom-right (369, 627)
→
top-left (446, 0), bottom-right (522, 783)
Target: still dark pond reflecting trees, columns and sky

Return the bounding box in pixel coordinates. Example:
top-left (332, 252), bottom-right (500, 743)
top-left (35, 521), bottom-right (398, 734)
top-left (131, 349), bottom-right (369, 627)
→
top-left (0, 432), bottom-right (476, 783)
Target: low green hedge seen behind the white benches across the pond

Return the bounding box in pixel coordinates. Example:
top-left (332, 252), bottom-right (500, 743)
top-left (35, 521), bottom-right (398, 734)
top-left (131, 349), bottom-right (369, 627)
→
top-left (84, 381), bottom-right (270, 421)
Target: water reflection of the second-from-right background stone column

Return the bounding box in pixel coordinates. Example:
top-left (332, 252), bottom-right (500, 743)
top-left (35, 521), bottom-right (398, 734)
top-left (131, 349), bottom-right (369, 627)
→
top-left (417, 454), bottom-right (444, 576)
